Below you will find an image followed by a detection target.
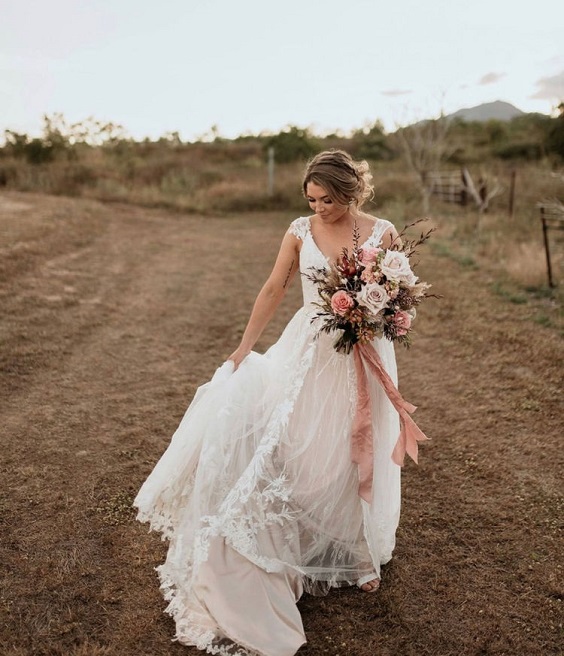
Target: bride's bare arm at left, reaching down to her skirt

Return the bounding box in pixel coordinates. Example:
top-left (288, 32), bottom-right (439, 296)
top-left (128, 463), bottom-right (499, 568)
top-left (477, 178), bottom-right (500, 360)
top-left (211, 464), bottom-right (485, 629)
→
top-left (227, 232), bottom-right (300, 369)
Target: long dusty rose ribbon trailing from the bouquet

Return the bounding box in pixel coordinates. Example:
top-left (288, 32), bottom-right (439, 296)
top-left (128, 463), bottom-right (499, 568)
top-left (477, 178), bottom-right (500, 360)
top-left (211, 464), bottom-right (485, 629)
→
top-left (351, 342), bottom-right (429, 503)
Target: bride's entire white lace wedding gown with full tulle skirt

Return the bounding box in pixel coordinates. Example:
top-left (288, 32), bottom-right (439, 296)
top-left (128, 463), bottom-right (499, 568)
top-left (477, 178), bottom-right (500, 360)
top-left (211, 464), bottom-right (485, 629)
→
top-left (134, 217), bottom-right (400, 656)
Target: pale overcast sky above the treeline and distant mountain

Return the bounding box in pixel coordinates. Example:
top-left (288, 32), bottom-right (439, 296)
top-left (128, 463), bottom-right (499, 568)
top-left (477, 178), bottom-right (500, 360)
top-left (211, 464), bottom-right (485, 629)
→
top-left (0, 0), bottom-right (564, 140)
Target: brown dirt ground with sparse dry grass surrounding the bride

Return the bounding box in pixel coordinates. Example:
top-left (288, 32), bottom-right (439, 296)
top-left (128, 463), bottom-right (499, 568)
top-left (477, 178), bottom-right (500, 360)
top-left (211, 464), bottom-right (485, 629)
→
top-left (0, 194), bottom-right (564, 656)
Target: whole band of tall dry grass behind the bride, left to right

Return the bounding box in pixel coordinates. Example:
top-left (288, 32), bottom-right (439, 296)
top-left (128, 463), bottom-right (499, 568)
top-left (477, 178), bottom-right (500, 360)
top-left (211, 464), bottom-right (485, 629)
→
top-left (0, 141), bottom-right (564, 303)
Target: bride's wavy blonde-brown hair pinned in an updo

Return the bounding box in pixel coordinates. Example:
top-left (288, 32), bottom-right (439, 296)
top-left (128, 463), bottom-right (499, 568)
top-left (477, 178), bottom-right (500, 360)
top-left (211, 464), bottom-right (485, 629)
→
top-left (302, 149), bottom-right (374, 208)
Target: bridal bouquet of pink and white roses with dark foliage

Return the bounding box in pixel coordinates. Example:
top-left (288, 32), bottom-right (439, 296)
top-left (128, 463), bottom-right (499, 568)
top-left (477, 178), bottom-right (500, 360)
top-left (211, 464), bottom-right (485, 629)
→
top-left (306, 221), bottom-right (433, 353)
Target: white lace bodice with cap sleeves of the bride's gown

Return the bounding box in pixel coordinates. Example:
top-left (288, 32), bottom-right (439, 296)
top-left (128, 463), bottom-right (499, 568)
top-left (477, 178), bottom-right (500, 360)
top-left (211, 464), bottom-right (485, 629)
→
top-left (289, 216), bottom-right (393, 311)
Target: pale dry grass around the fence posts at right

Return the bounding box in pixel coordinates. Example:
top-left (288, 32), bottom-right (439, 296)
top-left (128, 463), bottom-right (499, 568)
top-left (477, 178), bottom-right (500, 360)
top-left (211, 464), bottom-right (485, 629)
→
top-left (388, 166), bottom-right (564, 331)
